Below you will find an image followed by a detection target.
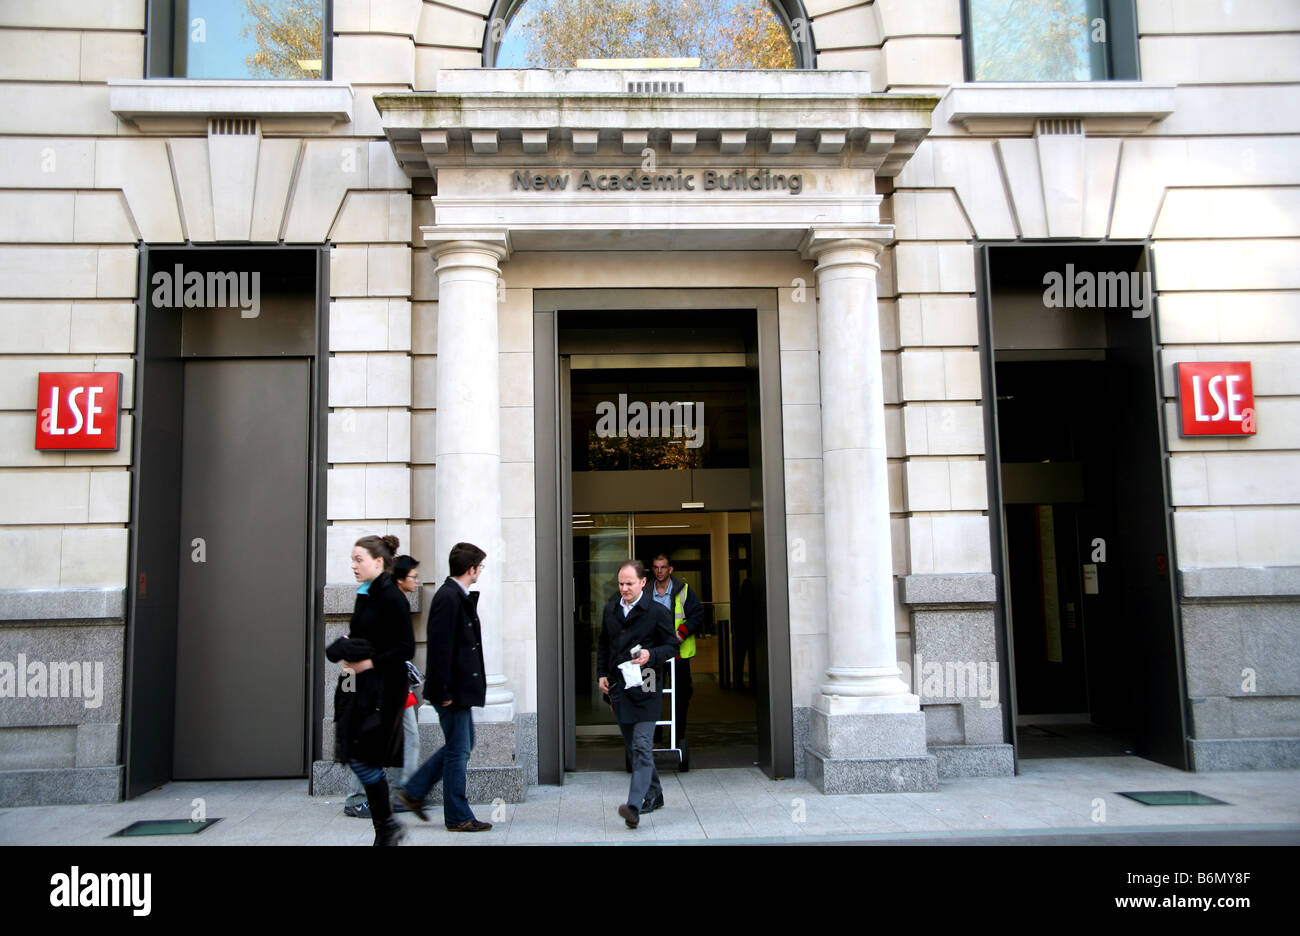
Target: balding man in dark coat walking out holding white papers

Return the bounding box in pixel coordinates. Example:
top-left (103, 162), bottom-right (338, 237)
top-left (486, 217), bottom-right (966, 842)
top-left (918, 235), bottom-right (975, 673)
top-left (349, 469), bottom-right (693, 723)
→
top-left (595, 559), bottom-right (677, 828)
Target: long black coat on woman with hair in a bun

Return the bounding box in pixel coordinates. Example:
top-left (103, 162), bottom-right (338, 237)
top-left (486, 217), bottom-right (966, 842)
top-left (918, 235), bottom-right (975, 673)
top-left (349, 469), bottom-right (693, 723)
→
top-left (326, 572), bottom-right (415, 767)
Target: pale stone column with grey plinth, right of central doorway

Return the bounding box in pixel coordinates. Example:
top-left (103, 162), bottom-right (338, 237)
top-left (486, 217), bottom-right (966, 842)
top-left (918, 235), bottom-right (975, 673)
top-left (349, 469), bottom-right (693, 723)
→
top-left (803, 225), bottom-right (937, 793)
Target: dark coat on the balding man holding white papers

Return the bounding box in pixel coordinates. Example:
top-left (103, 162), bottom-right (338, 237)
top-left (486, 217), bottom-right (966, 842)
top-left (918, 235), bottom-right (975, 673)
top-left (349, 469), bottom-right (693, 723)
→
top-left (595, 588), bottom-right (677, 724)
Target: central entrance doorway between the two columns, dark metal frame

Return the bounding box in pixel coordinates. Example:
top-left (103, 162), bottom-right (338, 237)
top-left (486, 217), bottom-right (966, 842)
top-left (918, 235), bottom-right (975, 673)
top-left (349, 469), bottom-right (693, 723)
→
top-left (534, 290), bottom-right (793, 783)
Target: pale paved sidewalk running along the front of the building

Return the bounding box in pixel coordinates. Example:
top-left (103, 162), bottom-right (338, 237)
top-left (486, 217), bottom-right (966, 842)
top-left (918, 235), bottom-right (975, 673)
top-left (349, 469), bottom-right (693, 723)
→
top-left (0, 757), bottom-right (1300, 845)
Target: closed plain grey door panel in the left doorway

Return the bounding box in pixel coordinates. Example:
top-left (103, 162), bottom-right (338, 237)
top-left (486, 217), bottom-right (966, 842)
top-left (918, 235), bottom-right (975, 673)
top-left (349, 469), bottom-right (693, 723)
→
top-left (173, 359), bottom-right (311, 780)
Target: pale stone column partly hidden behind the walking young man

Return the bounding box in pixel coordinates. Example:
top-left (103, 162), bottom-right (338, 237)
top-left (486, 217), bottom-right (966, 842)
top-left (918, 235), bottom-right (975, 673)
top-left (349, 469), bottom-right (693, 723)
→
top-left (425, 229), bottom-right (515, 722)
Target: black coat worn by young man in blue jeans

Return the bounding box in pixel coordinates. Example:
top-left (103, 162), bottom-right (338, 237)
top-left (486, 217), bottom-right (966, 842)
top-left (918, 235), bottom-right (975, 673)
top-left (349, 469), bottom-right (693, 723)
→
top-left (424, 576), bottom-right (488, 709)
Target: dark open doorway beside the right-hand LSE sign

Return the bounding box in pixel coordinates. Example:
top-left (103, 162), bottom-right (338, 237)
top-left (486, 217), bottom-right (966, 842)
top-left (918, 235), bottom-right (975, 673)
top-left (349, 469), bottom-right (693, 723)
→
top-left (985, 246), bottom-right (1187, 768)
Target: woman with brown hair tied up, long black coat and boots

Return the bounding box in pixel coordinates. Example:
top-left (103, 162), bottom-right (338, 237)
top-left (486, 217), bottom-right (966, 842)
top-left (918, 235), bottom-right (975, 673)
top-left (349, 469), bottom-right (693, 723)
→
top-left (325, 536), bottom-right (415, 845)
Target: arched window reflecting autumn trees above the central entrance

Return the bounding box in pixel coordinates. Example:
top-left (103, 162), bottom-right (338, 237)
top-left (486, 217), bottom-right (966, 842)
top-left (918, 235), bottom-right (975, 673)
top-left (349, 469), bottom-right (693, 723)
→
top-left (484, 0), bottom-right (814, 69)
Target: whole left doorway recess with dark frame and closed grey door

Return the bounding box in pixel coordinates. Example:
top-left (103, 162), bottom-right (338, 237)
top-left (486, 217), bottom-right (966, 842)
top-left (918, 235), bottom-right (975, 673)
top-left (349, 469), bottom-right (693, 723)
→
top-left (124, 248), bottom-right (328, 797)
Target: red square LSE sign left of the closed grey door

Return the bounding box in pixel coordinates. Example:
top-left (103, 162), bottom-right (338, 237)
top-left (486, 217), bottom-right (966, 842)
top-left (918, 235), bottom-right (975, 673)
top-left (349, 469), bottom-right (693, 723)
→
top-left (36, 371), bottom-right (122, 451)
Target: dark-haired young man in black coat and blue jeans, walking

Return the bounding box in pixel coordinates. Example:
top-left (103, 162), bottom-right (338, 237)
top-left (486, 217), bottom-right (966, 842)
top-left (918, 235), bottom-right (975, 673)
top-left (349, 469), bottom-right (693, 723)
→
top-left (398, 543), bottom-right (491, 832)
